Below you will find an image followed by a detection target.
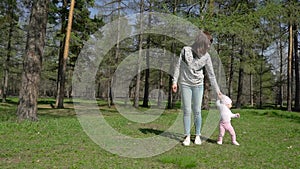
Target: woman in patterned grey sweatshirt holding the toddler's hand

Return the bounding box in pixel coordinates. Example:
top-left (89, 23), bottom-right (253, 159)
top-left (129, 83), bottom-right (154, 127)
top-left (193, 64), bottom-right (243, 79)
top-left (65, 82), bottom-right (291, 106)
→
top-left (172, 32), bottom-right (222, 146)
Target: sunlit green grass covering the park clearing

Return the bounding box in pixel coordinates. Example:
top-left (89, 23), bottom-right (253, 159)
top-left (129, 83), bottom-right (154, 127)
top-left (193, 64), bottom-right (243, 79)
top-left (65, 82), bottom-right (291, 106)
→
top-left (0, 100), bottom-right (300, 169)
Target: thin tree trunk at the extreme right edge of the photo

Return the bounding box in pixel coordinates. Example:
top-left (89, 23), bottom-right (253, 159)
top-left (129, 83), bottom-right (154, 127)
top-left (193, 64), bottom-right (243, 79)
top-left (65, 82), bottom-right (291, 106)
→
top-left (293, 24), bottom-right (300, 111)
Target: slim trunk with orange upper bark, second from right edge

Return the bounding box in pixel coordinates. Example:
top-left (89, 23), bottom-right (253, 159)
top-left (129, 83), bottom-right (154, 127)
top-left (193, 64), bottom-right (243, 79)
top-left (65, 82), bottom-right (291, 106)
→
top-left (287, 24), bottom-right (293, 111)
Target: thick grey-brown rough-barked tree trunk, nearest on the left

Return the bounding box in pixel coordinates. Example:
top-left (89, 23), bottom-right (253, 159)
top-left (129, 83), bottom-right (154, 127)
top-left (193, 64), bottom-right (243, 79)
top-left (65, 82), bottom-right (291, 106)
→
top-left (17, 0), bottom-right (48, 121)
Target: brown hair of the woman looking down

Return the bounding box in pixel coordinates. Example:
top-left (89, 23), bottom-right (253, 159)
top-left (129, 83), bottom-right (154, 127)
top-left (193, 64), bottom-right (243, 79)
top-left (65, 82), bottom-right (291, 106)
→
top-left (191, 32), bottom-right (212, 57)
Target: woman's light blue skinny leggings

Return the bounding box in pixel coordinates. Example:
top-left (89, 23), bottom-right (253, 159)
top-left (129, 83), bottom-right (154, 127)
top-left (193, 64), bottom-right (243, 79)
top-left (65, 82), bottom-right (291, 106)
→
top-left (181, 85), bottom-right (204, 136)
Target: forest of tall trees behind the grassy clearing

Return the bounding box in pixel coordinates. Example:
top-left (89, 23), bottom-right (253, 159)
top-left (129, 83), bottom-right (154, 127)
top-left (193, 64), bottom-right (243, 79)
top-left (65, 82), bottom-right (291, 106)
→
top-left (0, 0), bottom-right (300, 119)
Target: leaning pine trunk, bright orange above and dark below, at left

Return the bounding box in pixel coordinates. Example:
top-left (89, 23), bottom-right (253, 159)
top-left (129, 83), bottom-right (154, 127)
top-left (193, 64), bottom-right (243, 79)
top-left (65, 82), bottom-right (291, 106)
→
top-left (55, 0), bottom-right (75, 108)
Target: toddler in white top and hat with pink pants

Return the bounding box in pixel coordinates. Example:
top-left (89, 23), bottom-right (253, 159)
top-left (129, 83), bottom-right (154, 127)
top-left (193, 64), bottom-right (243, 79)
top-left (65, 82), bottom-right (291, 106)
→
top-left (216, 95), bottom-right (240, 145)
